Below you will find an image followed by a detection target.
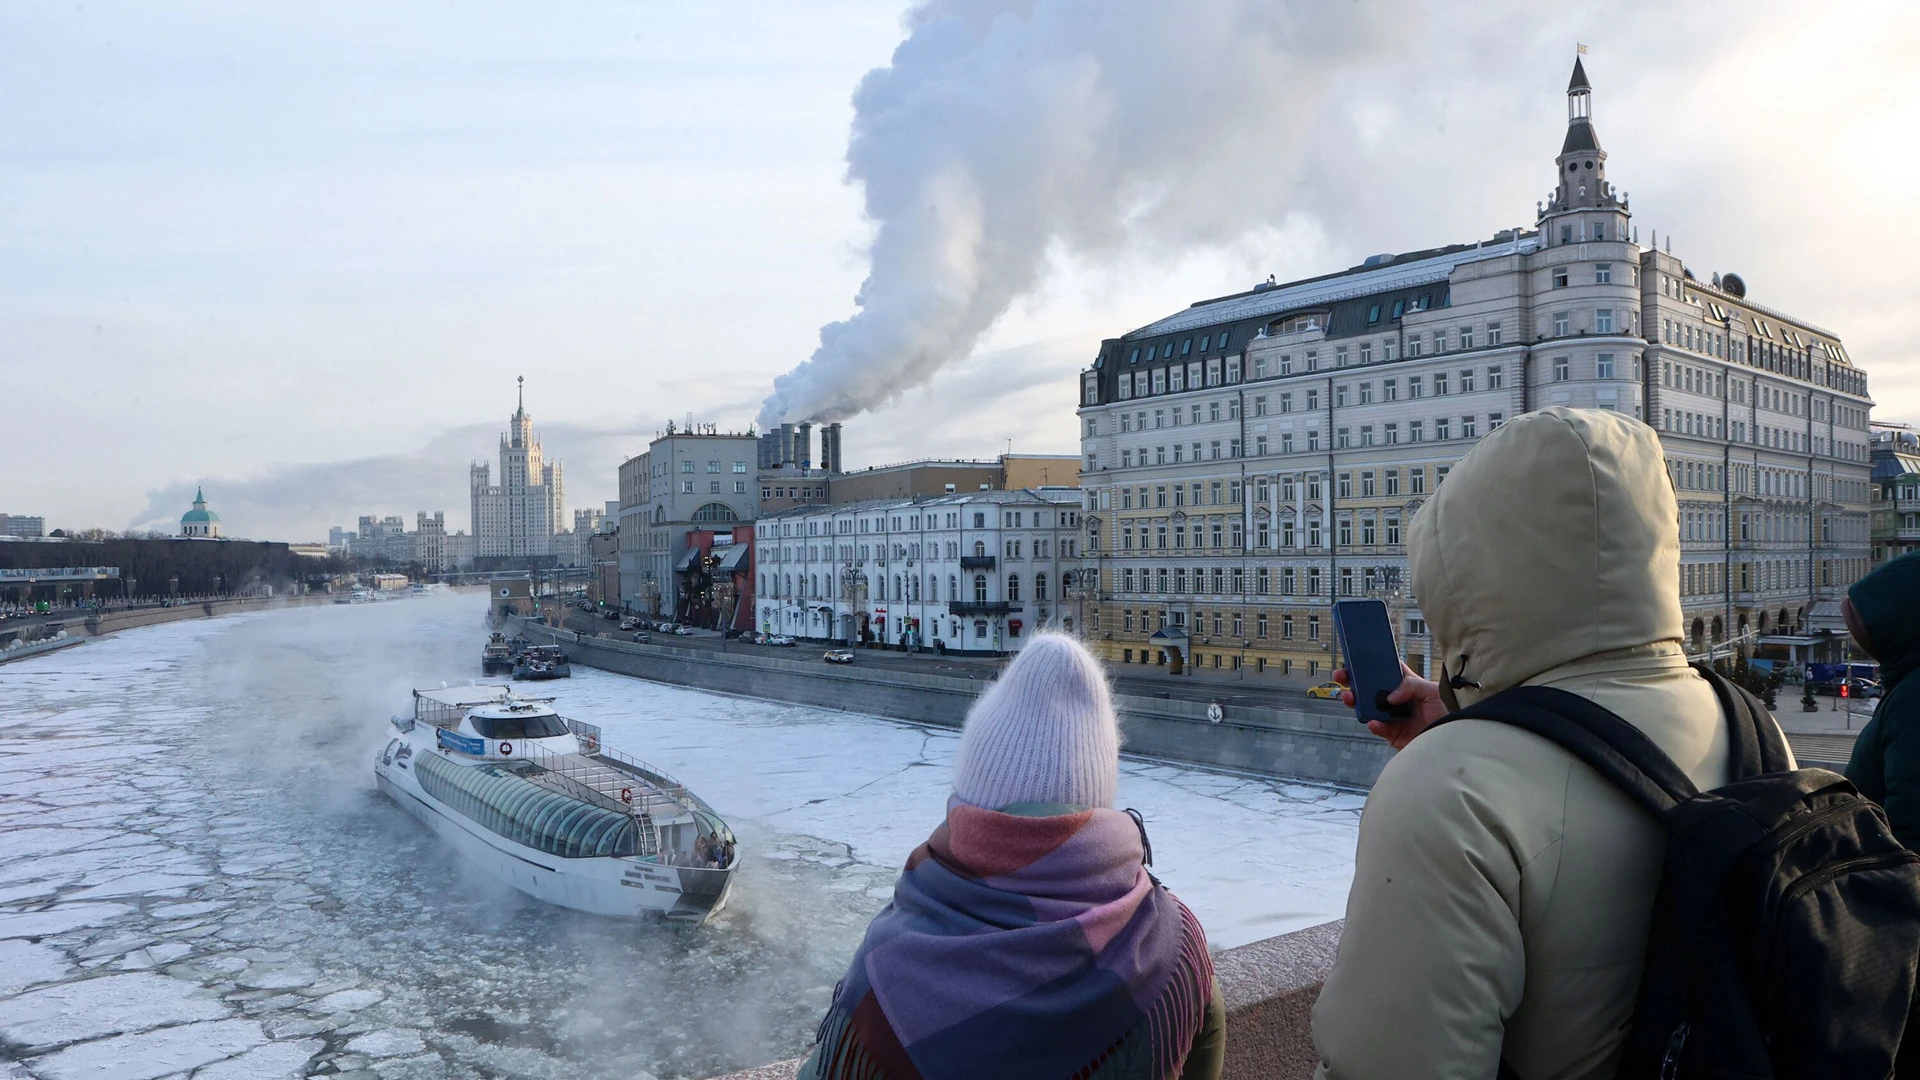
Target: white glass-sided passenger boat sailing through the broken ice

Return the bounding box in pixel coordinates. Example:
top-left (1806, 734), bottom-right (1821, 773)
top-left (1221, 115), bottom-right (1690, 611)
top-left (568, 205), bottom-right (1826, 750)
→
top-left (374, 686), bottom-right (739, 922)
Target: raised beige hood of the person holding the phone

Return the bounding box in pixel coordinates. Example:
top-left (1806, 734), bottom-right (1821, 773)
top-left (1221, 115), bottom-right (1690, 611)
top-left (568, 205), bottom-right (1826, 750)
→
top-left (1407, 407), bottom-right (1682, 707)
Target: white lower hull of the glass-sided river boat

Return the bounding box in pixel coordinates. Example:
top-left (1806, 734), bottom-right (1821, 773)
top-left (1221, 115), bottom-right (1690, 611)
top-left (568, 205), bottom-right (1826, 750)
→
top-left (374, 751), bottom-right (733, 922)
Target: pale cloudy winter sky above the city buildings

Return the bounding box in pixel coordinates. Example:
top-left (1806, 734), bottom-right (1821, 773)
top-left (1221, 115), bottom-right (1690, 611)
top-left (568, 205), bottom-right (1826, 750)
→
top-left (0, 0), bottom-right (1920, 540)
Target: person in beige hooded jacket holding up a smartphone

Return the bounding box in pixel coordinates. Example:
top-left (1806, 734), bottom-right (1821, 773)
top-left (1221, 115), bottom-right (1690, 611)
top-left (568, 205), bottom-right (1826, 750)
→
top-left (1313, 407), bottom-right (1789, 1080)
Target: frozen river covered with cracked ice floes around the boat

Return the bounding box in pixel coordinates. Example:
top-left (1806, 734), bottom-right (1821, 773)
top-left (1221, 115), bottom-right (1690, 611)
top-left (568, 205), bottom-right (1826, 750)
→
top-left (0, 596), bottom-right (1361, 1080)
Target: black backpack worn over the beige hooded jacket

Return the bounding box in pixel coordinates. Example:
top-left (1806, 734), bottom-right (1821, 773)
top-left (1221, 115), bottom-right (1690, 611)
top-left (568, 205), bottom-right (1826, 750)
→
top-left (1440, 667), bottom-right (1920, 1080)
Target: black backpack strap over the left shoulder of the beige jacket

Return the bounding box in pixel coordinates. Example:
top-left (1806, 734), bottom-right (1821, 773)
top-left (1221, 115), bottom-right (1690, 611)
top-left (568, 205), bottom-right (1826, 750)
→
top-left (1434, 686), bottom-right (1699, 815)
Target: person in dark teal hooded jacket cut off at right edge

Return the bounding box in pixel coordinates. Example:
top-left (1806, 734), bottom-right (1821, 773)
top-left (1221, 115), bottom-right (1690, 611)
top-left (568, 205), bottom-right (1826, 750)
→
top-left (1841, 552), bottom-right (1920, 849)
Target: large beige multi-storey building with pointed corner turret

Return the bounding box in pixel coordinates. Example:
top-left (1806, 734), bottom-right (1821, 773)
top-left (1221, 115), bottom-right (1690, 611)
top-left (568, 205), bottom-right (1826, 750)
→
top-left (1079, 60), bottom-right (1872, 678)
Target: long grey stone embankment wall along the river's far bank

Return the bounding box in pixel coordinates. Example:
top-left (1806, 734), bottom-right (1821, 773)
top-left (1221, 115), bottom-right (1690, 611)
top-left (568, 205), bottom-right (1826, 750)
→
top-left (522, 623), bottom-right (1392, 786)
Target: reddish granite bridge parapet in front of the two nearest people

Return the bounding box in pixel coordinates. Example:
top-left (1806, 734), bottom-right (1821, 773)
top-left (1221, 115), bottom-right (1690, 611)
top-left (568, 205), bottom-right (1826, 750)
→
top-left (714, 922), bottom-right (1342, 1080)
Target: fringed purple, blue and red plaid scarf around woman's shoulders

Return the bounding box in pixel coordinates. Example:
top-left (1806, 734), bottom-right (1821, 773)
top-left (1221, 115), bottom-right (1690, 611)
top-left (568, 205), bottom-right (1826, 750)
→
top-left (814, 799), bottom-right (1213, 1080)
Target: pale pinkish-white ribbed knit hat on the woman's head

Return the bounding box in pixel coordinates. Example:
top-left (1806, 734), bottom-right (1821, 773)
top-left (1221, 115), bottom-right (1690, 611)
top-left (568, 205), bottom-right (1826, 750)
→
top-left (954, 634), bottom-right (1119, 809)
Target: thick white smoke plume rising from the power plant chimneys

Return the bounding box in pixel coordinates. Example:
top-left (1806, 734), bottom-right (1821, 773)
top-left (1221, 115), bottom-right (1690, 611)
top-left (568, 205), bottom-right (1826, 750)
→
top-left (760, 0), bottom-right (1409, 425)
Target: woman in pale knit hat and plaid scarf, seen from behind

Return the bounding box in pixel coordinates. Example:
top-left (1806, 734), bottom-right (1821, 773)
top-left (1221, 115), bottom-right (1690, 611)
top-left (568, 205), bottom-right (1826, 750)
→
top-left (801, 634), bottom-right (1225, 1080)
